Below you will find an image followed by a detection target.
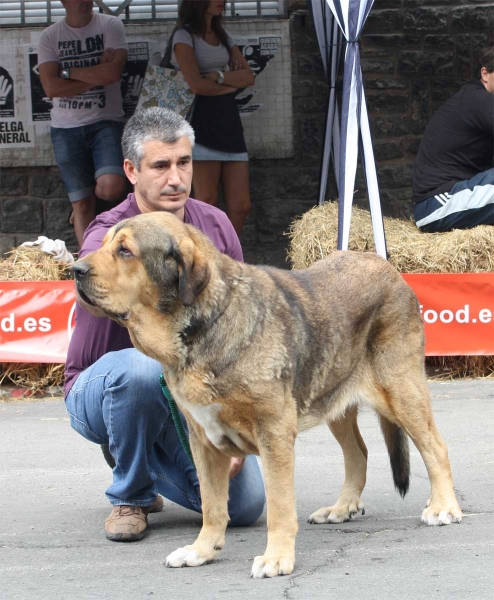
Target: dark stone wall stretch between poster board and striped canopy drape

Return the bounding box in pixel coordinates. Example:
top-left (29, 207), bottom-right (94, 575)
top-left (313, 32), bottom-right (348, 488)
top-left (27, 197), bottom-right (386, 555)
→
top-left (245, 0), bottom-right (330, 267)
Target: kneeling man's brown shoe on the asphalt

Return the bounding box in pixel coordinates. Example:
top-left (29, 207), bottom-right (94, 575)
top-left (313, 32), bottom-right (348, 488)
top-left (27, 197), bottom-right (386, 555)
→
top-left (105, 496), bottom-right (163, 542)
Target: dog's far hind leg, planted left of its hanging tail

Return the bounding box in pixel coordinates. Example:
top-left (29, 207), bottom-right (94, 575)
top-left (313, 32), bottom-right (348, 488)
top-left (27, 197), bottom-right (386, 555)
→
top-left (308, 406), bottom-right (367, 523)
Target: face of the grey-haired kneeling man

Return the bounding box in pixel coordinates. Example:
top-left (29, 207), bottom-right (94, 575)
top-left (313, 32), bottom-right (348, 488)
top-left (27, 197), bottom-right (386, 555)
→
top-left (124, 137), bottom-right (192, 220)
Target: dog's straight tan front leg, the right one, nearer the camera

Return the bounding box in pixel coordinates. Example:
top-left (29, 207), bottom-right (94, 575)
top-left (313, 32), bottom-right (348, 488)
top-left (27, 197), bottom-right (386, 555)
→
top-left (251, 423), bottom-right (298, 577)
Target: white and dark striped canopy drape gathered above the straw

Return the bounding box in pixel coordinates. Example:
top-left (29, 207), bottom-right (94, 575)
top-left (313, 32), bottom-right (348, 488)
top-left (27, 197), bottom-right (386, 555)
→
top-left (312, 0), bottom-right (387, 258)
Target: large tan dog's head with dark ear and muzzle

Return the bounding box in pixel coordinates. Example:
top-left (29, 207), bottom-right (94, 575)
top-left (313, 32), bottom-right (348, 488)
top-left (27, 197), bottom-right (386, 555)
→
top-left (73, 212), bottom-right (211, 326)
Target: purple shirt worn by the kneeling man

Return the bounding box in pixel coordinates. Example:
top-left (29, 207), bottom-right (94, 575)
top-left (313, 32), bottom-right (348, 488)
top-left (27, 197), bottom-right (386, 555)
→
top-left (65, 194), bottom-right (243, 395)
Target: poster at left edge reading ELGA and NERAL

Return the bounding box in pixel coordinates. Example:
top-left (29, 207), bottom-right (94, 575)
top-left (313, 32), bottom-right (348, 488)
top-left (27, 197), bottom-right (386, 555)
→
top-left (0, 51), bottom-right (34, 151)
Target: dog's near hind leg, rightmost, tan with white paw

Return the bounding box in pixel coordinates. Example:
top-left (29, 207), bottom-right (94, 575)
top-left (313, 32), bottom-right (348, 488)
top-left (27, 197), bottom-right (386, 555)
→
top-left (372, 378), bottom-right (462, 525)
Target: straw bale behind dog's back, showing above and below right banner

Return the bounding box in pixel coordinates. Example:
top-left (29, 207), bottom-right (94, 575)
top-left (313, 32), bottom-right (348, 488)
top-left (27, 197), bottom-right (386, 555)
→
top-left (288, 202), bottom-right (494, 379)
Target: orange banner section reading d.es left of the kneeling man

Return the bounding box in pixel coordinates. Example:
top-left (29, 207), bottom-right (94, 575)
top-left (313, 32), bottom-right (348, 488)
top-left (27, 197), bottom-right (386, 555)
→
top-left (0, 281), bottom-right (75, 363)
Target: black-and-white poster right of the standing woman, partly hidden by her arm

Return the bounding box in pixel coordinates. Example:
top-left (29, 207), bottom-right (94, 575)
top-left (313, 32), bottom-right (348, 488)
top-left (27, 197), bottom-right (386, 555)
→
top-left (235, 35), bottom-right (282, 116)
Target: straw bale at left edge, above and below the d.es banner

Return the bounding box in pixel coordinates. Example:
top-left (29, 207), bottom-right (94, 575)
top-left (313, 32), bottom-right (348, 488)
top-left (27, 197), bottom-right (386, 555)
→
top-left (0, 246), bottom-right (71, 396)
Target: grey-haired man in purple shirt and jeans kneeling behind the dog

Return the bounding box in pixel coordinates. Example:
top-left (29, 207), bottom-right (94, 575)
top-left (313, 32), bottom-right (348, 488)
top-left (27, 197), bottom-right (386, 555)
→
top-left (65, 108), bottom-right (265, 541)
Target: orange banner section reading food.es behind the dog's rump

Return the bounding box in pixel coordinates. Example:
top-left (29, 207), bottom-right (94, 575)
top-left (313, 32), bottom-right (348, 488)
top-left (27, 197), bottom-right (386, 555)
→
top-left (403, 273), bottom-right (494, 356)
